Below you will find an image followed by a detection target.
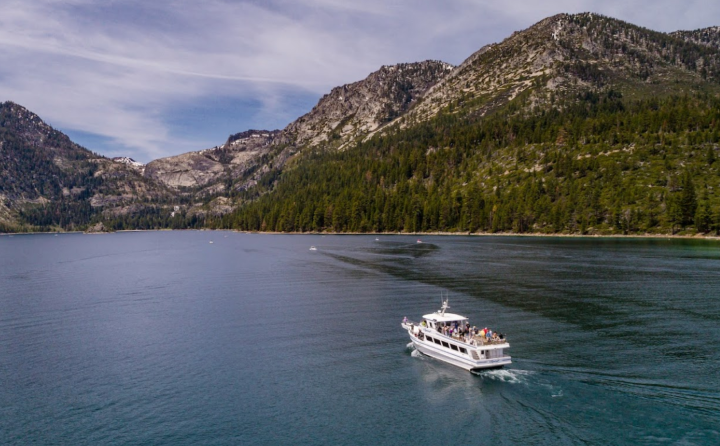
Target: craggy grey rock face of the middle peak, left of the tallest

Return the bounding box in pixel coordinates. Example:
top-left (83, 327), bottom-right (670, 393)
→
top-left (283, 60), bottom-right (454, 147)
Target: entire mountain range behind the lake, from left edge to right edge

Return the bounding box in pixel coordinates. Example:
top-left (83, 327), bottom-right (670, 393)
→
top-left (0, 13), bottom-right (720, 234)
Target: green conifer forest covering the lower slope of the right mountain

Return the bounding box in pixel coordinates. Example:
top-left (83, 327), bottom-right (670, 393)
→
top-left (218, 90), bottom-right (720, 234)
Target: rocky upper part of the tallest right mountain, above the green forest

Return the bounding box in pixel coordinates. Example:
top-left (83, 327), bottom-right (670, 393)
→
top-left (398, 13), bottom-right (720, 126)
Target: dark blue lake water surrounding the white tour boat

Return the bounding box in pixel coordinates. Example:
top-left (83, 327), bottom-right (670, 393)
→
top-left (0, 232), bottom-right (720, 446)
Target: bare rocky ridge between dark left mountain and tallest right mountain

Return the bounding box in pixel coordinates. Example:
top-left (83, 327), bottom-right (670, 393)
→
top-left (145, 61), bottom-right (453, 195)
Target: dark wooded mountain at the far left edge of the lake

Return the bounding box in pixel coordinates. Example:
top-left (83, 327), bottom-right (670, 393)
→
top-left (0, 102), bottom-right (172, 231)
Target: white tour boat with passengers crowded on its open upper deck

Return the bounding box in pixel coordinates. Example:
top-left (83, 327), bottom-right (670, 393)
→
top-left (401, 299), bottom-right (510, 371)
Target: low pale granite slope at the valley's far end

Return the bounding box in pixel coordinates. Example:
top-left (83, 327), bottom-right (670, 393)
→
top-left (144, 130), bottom-right (279, 193)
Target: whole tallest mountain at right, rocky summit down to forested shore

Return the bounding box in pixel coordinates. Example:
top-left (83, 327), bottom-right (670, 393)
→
top-left (220, 13), bottom-right (720, 234)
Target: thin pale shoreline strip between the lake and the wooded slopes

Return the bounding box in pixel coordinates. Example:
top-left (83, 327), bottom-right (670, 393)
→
top-left (0, 228), bottom-right (720, 241)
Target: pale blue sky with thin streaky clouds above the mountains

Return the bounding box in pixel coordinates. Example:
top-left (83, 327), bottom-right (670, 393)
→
top-left (0, 0), bottom-right (720, 163)
